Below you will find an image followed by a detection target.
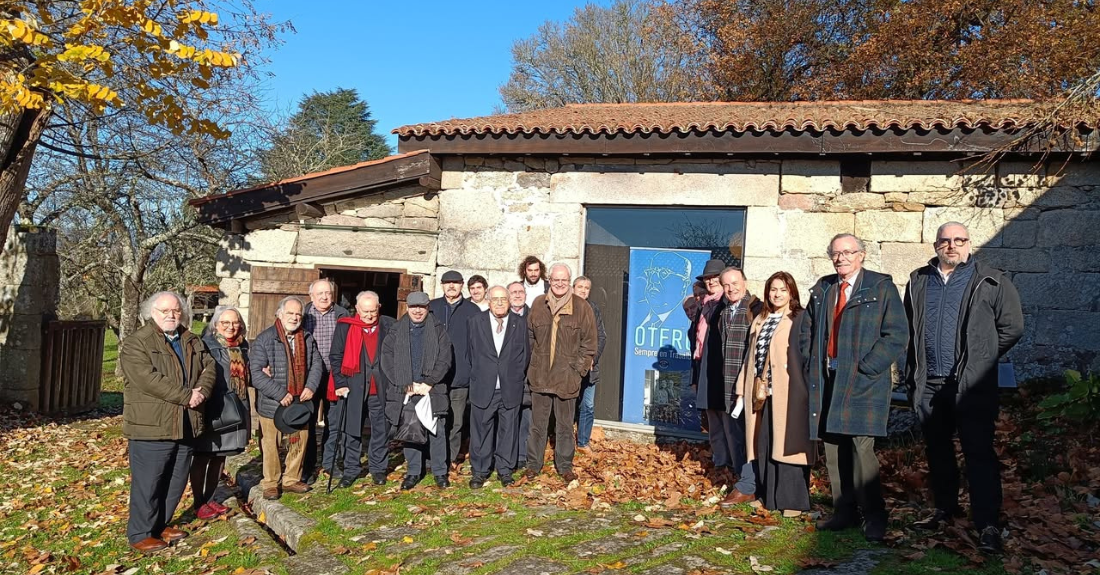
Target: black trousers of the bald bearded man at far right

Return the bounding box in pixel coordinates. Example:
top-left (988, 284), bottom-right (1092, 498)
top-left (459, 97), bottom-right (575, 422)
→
top-left (921, 379), bottom-right (1002, 530)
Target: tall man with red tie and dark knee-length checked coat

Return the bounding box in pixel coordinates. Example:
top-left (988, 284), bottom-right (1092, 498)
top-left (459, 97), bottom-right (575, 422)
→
top-left (802, 233), bottom-right (909, 541)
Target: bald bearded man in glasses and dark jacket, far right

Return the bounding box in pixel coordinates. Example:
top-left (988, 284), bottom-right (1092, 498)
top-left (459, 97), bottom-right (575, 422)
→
top-left (905, 222), bottom-right (1024, 553)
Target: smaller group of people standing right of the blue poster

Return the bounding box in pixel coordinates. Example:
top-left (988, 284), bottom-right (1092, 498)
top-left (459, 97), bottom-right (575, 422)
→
top-left (684, 222), bottom-right (1023, 553)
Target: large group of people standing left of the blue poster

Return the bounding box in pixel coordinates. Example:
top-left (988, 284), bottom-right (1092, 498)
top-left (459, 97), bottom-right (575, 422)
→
top-left (120, 256), bottom-right (605, 552)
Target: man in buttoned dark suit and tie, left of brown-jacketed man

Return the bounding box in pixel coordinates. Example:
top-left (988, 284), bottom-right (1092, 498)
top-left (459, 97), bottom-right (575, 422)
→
top-left (465, 286), bottom-right (528, 489)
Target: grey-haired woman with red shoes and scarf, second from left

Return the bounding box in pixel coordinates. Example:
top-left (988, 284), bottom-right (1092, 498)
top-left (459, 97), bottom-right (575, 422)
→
top-left (190, 307), bottom-right (252, 519)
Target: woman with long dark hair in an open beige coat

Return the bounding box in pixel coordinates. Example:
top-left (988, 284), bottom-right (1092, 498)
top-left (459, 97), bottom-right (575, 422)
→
top-left (737, 272), bottom-right (817, 517)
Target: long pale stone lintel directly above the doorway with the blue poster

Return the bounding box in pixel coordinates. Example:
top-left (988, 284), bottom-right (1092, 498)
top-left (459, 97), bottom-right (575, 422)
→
top-left (550, 167), bottom-right (779, 206)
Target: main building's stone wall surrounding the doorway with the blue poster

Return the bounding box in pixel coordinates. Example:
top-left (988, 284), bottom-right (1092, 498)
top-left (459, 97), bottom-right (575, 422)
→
top-left (432, 156), bottom-right (1100, 378)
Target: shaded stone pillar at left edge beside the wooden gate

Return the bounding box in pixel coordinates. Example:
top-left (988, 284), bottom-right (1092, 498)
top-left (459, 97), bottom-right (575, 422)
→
top-left (0, 226), bottom-right (61, 409)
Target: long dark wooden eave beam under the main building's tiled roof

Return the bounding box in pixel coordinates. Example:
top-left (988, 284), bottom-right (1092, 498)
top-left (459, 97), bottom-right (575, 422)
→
top-left (397, 128), bottom-right (1100, 156)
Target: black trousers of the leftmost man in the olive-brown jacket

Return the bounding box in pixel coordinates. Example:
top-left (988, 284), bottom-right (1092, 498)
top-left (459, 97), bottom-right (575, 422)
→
top-left (127, 440), bottom-right (191, 544)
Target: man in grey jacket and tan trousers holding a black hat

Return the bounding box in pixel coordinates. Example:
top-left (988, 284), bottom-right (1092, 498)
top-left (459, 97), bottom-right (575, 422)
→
top-left (249, 297), bottom-right (323, 499)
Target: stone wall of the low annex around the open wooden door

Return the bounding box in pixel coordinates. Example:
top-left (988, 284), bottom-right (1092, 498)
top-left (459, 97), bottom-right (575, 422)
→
top-left (217, 187), bottom-right (440, 321)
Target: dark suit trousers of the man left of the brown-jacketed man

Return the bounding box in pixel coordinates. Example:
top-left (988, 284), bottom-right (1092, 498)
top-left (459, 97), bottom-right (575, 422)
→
top-left (470, 389), bottom-right (519, 477)
